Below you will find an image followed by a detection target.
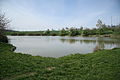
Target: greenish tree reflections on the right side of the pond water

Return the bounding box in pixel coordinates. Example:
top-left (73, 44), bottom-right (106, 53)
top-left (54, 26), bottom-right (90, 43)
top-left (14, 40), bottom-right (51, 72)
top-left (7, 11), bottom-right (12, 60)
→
top-left (60, 37), bottom-right (120, 52)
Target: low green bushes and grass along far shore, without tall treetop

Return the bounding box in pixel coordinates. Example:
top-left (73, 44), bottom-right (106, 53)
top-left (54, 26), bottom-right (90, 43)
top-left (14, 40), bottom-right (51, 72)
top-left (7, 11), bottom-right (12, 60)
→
top-left (6, 24), bottom-right (120, 37)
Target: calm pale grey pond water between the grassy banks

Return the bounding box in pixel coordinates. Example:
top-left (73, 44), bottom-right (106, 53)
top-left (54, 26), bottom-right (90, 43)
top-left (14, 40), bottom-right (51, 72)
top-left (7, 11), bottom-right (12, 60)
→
top-left (8, 36), bottom-right (120, 57)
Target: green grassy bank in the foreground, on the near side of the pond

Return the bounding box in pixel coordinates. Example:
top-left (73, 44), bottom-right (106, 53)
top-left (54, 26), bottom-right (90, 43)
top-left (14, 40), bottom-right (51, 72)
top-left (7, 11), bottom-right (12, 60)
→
top-left (0, 43), bottom-right (120, 80)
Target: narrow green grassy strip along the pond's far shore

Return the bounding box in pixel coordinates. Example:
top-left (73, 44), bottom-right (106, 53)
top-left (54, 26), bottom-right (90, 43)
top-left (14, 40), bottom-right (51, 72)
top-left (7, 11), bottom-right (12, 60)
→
top-left (5, 30), bottom-right (120, 38)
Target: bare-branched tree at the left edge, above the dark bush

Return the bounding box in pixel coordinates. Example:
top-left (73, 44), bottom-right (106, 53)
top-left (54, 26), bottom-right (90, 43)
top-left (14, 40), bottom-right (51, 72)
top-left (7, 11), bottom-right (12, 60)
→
top-left (0, 13), bottom-right (10, 35)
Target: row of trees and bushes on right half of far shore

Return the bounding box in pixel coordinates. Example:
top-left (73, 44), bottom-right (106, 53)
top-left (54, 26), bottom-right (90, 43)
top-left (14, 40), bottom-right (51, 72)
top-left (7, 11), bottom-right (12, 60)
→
top-left (43, 19), bottom-right (120, 36)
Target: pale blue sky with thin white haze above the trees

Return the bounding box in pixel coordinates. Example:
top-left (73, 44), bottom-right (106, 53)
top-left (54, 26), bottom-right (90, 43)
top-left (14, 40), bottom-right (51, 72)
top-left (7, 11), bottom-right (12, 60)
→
top-left (0, 0), bottom-right (120, 31)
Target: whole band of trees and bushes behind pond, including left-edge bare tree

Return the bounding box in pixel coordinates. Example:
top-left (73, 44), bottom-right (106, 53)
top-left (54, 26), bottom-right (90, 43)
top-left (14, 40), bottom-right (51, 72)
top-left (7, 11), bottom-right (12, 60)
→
top-left (0, 13), bottom-right (120, 43)
